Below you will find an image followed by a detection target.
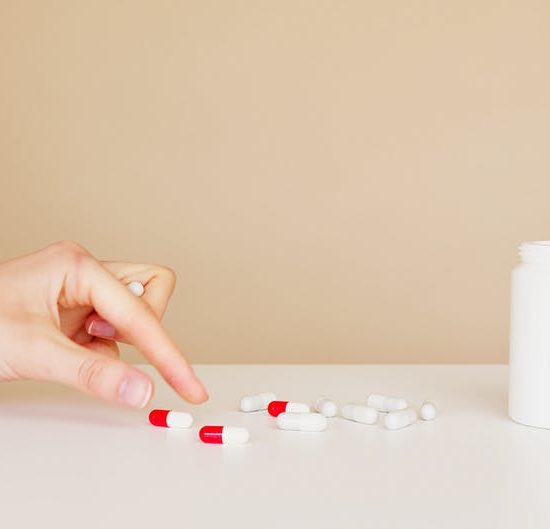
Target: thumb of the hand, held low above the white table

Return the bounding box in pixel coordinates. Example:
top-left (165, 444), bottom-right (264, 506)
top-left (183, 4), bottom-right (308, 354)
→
top-left (44, 337), bottom-right (153, 408)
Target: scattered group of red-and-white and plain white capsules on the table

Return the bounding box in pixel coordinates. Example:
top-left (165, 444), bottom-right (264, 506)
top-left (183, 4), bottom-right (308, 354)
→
top-left (149, 393), bottom-right (437, 444)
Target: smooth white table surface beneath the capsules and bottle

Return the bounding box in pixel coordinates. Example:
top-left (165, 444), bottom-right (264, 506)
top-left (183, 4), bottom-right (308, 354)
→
top-left (0, 365), bottom-right (550, 529)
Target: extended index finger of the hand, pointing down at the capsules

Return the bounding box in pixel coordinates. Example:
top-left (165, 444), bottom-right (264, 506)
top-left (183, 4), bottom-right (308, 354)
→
top-left (66, 256), bottom-right (208, 403)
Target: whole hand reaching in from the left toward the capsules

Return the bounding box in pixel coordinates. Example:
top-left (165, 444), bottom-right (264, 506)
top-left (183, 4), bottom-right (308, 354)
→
top-left (0, 241), bottom-right (208, 408)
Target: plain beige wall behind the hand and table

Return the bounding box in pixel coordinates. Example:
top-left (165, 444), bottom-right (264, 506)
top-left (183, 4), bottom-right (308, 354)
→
top-left (0, 0), bottom-right (550, 362)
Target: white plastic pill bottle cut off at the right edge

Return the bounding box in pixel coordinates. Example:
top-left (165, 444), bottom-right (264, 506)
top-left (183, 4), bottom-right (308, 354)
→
top-left (508, 241), bottom-right (550, 428)
